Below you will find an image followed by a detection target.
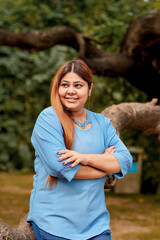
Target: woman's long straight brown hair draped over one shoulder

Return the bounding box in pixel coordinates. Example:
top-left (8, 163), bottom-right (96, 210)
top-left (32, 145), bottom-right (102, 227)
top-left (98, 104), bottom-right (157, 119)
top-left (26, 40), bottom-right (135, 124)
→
top-left (46, 59), bottom-right (93, 186)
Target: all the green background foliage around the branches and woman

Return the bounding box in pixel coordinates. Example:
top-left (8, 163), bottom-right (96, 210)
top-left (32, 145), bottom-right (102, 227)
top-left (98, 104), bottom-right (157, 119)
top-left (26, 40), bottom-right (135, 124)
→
top-left (0, 0), bottom-right (160, 191)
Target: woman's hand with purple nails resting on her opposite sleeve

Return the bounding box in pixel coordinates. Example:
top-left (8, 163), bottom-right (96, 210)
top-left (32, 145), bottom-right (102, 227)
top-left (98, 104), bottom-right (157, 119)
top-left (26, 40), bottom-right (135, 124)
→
top-left (57, 149), bottom-right (88, 167)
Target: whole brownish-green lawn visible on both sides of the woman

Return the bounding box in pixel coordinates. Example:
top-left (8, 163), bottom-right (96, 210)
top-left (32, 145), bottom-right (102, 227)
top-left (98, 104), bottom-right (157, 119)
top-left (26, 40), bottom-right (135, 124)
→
top-left (0, 172), bottom-right (160, 240)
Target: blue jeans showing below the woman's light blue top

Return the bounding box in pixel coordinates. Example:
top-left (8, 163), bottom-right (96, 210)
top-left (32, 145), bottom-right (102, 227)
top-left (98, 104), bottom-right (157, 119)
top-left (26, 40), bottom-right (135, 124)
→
top-left (32, 222), bottom-right (111, 240)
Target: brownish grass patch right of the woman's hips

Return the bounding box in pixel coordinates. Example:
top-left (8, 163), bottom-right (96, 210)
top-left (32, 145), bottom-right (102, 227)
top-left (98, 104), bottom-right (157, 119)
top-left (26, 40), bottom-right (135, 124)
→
top-left (106, 193), bottom-right (160, 240)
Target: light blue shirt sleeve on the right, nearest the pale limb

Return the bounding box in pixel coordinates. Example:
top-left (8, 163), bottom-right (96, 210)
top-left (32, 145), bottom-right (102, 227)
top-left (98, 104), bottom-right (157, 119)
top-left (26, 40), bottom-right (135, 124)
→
top-left (105, 118), bottom-right (133, 179)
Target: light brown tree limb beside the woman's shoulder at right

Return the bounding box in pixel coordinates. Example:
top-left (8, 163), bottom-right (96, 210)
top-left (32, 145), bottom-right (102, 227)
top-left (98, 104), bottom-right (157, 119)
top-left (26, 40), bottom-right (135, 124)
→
top-left (102, 99), bottom-right (160, 141)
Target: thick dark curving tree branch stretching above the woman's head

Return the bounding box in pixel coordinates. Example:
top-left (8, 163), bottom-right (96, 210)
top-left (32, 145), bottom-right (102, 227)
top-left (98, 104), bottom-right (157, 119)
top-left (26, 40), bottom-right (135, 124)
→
top-left (0, 13), bottom-right (160, 98)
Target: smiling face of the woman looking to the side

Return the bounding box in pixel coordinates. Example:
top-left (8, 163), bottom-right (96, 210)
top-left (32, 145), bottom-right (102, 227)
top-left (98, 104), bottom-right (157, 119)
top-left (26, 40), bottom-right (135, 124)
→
top-left (59, 72), bottom-right (92, 112)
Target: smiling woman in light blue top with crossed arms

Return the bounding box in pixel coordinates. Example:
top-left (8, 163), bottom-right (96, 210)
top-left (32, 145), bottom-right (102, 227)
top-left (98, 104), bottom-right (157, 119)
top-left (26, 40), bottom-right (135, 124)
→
top-left (27, 60), bottom-right (132, 240)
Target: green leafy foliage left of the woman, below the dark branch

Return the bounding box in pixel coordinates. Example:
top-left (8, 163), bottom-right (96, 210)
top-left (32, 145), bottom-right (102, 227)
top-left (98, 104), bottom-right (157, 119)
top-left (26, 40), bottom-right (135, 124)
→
top-left (0, 47), bottom-right (76, 171)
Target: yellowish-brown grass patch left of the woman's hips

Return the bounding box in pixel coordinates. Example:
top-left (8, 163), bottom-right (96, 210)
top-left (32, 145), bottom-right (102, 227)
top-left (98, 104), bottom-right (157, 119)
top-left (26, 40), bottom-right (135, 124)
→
top-left (0, 172), bottom-right (33, 227)
